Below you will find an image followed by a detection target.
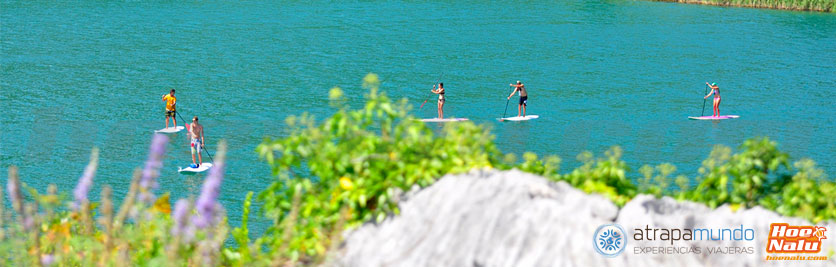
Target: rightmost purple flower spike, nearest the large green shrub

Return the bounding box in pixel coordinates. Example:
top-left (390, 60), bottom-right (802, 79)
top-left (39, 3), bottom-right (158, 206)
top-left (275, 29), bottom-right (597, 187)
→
top-left (194, 159), bottom-right (224, 228)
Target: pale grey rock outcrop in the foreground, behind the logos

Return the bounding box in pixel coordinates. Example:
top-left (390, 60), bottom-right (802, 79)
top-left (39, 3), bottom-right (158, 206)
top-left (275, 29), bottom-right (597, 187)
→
top-left (334, 170), bottom-right (836, 267)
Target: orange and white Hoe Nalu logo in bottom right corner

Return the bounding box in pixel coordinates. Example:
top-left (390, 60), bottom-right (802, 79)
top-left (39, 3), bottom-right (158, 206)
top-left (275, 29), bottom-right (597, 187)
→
top-left (766, 223), bottom-right (827, 253)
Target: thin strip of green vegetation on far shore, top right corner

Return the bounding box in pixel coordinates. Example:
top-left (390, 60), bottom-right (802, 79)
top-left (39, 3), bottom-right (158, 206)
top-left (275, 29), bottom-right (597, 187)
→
top-left (651, 0), bottom-right (836, 12)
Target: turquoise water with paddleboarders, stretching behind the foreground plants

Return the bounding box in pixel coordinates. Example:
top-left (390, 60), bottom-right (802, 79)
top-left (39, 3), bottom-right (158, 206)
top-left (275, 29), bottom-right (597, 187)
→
top-left (0, 1), bottom-right (836, 234)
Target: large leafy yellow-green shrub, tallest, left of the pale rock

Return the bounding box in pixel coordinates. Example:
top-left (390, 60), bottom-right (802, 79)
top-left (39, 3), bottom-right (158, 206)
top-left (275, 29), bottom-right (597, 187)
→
top-left (257, 74), bottom-right (500, 262)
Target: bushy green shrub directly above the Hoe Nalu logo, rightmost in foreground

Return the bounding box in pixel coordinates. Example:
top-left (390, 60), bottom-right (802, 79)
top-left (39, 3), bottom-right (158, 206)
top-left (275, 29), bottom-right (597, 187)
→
top-left (674, 137), bottom-right (836, 222)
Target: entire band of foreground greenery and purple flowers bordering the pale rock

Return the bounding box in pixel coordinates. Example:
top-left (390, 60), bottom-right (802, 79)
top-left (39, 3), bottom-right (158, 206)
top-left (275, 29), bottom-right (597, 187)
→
top-left (0, 75), bottom-right (836, 266)
